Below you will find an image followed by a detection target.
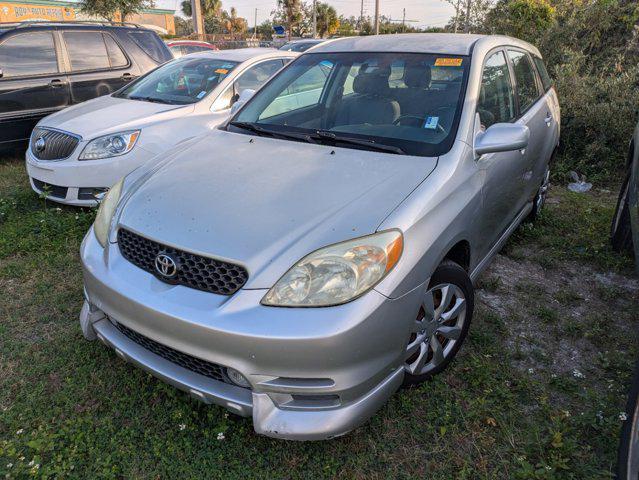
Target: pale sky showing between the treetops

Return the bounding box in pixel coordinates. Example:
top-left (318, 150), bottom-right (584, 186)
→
top-left (155, 0), bottom-right (460, 27)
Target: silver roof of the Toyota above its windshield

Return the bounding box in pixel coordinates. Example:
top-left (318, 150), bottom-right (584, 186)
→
top-left (309, 33), bottom-right (539, 55)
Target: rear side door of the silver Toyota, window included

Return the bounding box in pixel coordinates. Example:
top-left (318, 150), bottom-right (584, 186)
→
top-left (508, 49), bottom-right (548, 204)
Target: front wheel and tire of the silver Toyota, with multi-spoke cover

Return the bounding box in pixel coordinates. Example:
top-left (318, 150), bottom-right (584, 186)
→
top-left (404, 260), bottom-right (475, 386)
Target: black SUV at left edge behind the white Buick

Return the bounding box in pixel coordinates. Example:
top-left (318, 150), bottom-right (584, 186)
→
top-left (0, 22), bottom-right (173, 150)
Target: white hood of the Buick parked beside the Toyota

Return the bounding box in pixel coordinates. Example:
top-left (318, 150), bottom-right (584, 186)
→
top-left (40, 95), bottom-right (194, 140)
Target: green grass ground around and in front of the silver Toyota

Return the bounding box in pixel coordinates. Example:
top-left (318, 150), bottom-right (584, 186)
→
top-left (0, 160), bottom-right (637, 479)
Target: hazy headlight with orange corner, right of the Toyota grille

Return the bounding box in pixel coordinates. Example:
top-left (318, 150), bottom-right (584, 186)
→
top-left (262, 230), bottom-right (404, 307)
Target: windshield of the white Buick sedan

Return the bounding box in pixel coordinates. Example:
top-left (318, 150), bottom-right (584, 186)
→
top-left (115, 57), bottom-right (238, 105)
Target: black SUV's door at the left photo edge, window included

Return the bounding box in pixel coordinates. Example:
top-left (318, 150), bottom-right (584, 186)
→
top-left (0, 31), bottom-right (69, 147)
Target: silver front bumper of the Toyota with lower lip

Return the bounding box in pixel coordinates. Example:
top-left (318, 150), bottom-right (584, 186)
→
top-left (80, 230), bottom-right (421, 440)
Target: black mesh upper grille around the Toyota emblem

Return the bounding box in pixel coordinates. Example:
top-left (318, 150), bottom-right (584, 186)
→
top-left (118, 228), bottom-right (248, 295)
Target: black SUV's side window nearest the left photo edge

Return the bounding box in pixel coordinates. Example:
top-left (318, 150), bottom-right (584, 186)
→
top-left (0, 32), bottom-right (58, 78)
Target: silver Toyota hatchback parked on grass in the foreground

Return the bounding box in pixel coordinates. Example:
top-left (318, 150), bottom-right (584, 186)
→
top-left (80, 34), bottom-right (559, 440)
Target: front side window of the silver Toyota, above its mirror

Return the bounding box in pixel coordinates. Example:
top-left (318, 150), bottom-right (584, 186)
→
top-left (477, 52), bottom-right (515, 128)
